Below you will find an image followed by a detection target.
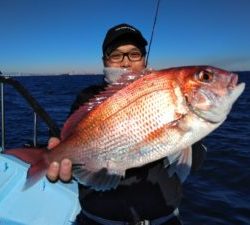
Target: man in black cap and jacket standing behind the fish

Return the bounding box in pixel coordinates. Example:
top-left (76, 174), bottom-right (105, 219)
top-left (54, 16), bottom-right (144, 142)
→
top-left (47, 24), bottom-right (204, 225)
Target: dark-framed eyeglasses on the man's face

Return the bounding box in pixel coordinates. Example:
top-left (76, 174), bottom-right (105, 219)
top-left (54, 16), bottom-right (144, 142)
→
top-left (107, 50), bottom-right (143, 63)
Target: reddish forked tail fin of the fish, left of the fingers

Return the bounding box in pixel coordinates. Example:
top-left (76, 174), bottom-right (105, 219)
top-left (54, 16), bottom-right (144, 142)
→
top-left (4, 148), bottom-right (49, 190)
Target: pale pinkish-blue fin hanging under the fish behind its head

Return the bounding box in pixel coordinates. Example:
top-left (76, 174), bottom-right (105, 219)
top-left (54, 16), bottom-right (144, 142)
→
top-left (165, 147), bottom-right (192, 183)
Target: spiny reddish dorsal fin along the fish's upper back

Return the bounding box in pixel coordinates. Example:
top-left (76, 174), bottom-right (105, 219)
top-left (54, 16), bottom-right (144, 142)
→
top-left (61, 70), bottom-right (152, 140)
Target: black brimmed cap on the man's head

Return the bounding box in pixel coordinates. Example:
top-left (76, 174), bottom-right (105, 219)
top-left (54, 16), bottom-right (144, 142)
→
top-left (102, 23), bottom-right (148, 56)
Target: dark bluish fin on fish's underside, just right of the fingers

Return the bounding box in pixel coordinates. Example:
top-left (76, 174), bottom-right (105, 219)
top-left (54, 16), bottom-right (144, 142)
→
top-left (73, 164), bottom-right (123, 191)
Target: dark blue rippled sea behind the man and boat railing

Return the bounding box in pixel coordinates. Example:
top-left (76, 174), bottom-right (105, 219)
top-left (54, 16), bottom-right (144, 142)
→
top-left (0, 72), bottom-right (250, 225)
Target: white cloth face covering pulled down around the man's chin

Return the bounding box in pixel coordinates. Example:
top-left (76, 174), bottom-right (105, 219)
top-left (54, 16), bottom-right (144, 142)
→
top-left (103, 67), bottom-right (131, 84)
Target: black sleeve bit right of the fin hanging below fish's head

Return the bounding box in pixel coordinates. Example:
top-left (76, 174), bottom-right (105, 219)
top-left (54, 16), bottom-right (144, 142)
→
top-left (191, 141), bottom-right (207, 172)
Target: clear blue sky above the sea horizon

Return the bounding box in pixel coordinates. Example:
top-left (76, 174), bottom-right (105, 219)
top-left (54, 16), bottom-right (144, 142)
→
top-left (0, 0), bottom-right (250, 73)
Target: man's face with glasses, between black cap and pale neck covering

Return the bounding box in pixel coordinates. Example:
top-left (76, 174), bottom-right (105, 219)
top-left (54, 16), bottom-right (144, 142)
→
top-left (103, 44), bottom-right (146, 72)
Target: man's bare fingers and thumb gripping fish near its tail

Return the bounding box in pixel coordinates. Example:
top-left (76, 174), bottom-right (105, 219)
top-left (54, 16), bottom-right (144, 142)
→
top-left (47, 137), bottom-right (72, 182)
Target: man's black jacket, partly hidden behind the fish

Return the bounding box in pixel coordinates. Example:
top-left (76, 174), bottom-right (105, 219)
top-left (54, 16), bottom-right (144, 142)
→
top-left (71, 83), bottom-right (205, 221)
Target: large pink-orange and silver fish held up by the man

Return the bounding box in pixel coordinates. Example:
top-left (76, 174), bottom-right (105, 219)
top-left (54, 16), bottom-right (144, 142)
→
top-left (4, 66), bottom-right (244, 190)
